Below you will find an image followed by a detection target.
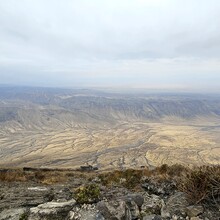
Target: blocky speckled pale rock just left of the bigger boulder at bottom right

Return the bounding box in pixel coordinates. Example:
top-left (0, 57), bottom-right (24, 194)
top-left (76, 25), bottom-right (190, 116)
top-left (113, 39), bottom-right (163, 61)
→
top-left (141, 194), bottom-right (162, 215)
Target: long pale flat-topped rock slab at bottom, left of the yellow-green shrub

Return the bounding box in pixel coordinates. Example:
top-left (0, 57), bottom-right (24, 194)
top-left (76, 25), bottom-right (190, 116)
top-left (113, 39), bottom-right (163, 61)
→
top-left (28, 199), bottom-right (76, 220)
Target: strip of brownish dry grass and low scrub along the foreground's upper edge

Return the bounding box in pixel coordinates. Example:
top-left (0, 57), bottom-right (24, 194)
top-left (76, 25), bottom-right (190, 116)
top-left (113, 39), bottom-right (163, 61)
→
top-left (0, 165), bottom-right (184, 186)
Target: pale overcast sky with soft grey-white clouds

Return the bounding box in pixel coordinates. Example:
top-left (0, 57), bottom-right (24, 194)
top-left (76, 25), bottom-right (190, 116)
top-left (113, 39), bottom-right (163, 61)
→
top-left (0, 0), bottom-right (220, 92)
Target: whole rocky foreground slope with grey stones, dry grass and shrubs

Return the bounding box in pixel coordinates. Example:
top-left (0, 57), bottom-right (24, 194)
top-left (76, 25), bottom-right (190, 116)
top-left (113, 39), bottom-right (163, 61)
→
top-left (0, 166), bottom-right (220, 220)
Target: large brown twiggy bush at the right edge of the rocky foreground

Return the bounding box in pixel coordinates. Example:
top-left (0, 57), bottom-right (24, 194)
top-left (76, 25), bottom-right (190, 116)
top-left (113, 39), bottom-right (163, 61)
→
top-left (178, 166), bottom-right (220, 205)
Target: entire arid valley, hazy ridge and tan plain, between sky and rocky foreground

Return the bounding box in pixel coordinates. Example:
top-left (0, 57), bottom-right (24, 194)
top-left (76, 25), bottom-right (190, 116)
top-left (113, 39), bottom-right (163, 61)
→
top-left (0, 88), bottom-right (220, 169)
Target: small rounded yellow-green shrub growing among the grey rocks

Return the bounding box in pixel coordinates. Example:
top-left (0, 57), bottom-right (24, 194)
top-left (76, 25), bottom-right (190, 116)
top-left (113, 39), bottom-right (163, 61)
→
top-left (74, 184), bottom-right (101, 204)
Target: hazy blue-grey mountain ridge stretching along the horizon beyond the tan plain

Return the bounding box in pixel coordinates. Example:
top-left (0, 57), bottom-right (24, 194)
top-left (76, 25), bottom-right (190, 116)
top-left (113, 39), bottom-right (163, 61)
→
top-left (0, 87), bottom-right (220, 124)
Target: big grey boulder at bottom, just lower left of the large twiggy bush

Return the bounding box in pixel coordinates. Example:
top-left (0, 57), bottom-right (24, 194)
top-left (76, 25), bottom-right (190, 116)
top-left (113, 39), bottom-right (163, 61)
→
top-left (161, 192), bottom-right (189, 218)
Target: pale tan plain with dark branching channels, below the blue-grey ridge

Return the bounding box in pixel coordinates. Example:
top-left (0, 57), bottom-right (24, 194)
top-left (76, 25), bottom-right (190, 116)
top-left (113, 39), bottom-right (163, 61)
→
top-left (0, 118), bottom-right (220, 169)
